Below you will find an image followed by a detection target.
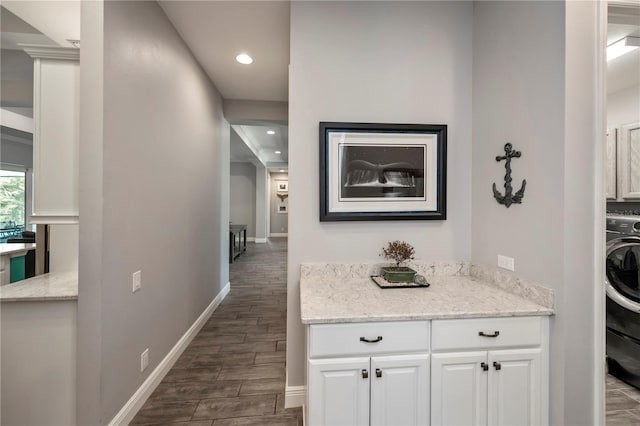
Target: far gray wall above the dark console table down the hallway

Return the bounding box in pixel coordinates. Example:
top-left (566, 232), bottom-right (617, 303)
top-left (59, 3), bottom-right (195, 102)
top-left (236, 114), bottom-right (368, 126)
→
top-left (229, 163), bottom-right (256, 237)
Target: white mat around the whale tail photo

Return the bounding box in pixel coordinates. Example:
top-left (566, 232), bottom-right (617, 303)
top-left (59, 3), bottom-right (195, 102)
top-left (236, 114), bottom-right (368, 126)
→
top-left (327, 131), bottom-right (438, 213)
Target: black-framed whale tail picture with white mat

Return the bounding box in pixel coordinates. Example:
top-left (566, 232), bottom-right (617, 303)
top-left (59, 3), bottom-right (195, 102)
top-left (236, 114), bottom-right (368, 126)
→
top-left (319, 121), bottom-right (447, 222)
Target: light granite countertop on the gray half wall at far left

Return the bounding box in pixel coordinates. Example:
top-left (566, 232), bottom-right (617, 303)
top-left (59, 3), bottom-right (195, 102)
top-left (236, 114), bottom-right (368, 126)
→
top-left (0, 271), bottom-right (78, 303)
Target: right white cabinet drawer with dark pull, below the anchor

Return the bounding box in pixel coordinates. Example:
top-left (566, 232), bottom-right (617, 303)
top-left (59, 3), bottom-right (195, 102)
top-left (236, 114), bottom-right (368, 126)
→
top-left (431, 317), bottom-right (542, 351)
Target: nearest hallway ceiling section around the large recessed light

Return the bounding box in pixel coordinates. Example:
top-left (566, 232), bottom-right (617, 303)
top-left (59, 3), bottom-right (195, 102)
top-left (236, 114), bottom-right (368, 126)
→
top-left (160, 0), bottom-right (290, 102)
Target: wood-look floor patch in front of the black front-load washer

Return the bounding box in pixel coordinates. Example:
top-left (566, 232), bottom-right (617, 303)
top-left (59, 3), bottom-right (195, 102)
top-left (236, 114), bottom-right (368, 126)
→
top-left (606, 375), bottom-right (640, 426)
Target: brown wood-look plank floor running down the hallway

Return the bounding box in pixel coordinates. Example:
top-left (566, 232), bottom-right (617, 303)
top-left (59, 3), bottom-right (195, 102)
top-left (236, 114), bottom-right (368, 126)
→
top-left (131, 238), bottom-right (302, 426)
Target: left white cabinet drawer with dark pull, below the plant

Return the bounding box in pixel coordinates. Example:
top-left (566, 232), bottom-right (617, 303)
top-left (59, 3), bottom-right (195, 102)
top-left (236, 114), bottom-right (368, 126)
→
top-left (309, 321), bottom-right (430, 358)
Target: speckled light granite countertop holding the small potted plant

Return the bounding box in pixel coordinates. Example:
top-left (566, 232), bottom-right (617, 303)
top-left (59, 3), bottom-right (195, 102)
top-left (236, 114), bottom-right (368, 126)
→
top-left (300, 275), bottom-right (553, 324)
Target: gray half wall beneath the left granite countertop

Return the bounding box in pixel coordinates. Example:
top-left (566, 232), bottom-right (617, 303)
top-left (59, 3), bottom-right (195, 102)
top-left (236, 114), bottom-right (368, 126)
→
top-left (0, 300), bottom-right (80, 426)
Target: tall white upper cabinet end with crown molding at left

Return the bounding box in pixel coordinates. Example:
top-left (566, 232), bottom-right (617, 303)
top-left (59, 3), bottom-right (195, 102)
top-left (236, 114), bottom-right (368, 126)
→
top-left (25, 46), bottom-right (80, 224)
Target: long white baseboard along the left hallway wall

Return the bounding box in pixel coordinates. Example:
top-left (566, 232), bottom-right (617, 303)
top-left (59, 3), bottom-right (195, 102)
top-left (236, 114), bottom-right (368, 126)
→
top-left (109, 283), bottom-right (231, 425)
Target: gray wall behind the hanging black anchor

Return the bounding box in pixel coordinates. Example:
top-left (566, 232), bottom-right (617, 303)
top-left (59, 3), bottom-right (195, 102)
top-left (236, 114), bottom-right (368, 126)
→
top-left (472, 2), bottom-right (564, 419)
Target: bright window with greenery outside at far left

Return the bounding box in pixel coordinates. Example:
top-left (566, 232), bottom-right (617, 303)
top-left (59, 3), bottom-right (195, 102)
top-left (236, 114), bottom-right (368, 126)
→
top-left (0, 170), bottom-right (27, 243)
